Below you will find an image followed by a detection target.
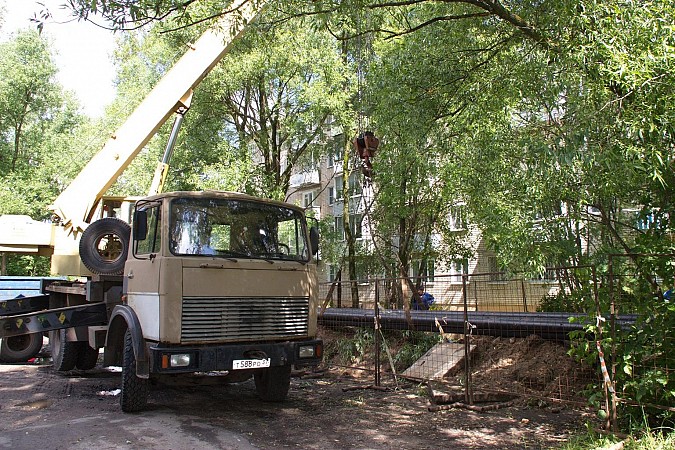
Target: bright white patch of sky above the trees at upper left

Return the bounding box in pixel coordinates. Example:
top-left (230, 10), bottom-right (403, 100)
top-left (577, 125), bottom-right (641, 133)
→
top-left (0, 0), bottom-right (115, 117)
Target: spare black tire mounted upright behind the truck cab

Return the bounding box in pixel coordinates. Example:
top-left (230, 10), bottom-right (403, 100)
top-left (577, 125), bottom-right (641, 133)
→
top-left (80, 217), bottom-right (131, 275)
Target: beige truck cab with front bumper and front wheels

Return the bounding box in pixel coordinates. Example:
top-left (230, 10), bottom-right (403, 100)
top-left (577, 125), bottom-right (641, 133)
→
top-left (104, 191), bottom-right (322, 411)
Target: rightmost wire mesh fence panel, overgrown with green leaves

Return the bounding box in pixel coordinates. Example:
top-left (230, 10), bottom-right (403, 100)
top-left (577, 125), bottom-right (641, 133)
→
top-left (608, 254), bottom-right (675, 428)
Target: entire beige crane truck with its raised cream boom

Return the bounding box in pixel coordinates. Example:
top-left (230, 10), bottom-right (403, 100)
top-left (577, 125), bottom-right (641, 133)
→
top-left (0, 1), bottom-right (323, 412)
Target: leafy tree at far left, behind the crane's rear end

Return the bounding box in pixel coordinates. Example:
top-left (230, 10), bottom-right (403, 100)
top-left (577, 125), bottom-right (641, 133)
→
top-left (0, 31), bottom-right (83, 275)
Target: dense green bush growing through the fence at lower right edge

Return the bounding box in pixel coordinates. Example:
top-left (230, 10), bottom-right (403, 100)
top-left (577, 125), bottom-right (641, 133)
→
top-left (564, 255), bottom-right (675, 429)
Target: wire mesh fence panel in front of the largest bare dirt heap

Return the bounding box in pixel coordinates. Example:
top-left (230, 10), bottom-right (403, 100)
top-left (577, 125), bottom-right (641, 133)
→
top-left (465, 268), bottom-right (596, 401)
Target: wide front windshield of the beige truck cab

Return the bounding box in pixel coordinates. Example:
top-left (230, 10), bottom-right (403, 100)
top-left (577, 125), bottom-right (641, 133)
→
top-left (169, 198), bottom-right (309, 261)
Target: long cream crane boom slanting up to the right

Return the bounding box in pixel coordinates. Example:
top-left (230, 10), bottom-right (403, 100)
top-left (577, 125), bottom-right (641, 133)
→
top-left (49, 0), bottom-right (262, 235)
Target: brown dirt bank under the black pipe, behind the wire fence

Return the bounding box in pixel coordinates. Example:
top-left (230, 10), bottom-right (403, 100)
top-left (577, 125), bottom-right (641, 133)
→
top-left (321, 328), bottom-right (597, 403)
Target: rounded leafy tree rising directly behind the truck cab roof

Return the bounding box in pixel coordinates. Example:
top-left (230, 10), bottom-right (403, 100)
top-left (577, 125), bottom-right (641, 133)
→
top-left (187, 18), bottom-right (348, 199)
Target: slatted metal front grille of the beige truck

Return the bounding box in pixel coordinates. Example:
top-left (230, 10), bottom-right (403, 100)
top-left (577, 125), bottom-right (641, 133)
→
top-left (181, 297), bottom-right (309, 342)
